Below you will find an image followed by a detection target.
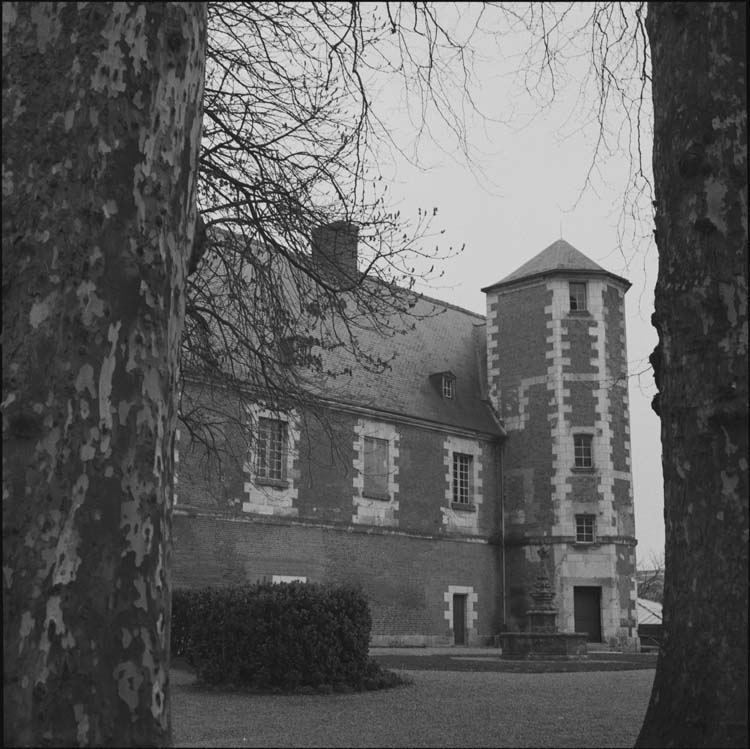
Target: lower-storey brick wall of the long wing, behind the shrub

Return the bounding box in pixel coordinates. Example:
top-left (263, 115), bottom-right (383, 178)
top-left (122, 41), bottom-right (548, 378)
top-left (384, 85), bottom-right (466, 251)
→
top-left (172, 514), bottom-right (502, 644)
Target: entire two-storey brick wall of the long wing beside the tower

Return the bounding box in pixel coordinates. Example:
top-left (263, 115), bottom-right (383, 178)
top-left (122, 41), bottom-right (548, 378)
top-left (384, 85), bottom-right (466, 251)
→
top-left (172, 386), bottom-right (502, 644)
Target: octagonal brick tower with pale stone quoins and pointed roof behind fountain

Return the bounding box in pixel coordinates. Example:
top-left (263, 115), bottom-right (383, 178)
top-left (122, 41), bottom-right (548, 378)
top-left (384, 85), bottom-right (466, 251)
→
top-left (483, 239), bottom-right (637, 649)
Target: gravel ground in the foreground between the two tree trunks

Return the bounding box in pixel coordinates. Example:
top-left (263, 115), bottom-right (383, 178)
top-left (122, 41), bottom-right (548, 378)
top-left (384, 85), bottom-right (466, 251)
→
top-left (172, 656), bottom-right (654, 747)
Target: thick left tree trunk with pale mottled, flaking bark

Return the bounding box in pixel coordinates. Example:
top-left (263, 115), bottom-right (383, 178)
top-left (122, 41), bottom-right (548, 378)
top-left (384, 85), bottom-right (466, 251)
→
top-left (2, 3), bottom-right (206, 746)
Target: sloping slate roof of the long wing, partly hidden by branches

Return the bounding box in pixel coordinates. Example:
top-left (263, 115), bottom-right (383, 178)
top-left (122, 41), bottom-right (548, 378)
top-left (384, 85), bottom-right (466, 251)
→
top-left (189, 231), bottom-right (505, 437)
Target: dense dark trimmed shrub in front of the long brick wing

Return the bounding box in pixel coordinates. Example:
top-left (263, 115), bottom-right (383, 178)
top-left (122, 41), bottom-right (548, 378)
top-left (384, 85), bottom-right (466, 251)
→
top-left (171, 582), bottom-right (373, 691)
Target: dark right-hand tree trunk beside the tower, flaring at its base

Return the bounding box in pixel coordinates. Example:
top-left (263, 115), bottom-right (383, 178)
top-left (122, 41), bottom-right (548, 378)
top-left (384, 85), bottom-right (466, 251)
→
top-left (638, 3), bottom-right (748, 747)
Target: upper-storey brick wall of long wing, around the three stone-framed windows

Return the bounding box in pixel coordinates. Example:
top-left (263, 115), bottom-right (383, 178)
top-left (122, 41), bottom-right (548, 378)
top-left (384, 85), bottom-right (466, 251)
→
top-left (176, 388), bottom-right (500, 537)
